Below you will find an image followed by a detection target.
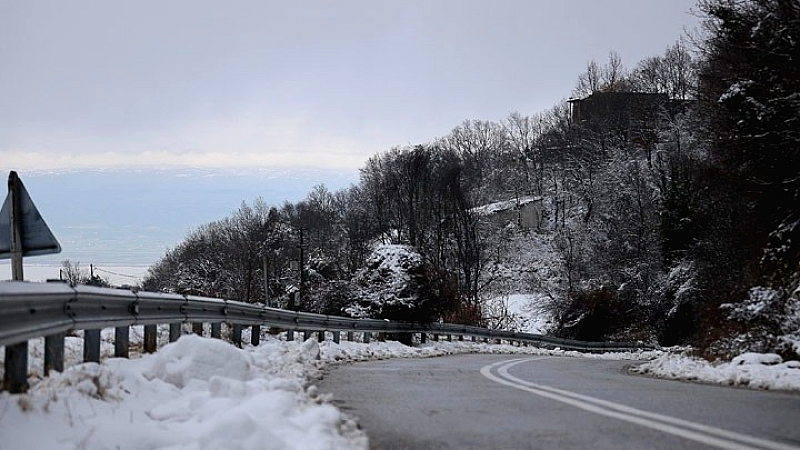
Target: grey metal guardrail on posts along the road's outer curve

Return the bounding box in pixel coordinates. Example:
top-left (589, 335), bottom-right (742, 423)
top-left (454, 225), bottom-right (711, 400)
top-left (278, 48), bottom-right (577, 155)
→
top-left (0, 281), bottom-right (653, 392)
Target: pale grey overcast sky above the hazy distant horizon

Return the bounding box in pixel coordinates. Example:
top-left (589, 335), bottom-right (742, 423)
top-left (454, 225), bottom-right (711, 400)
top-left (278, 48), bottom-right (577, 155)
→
top-left (0, 0), bottom-right (698, 171)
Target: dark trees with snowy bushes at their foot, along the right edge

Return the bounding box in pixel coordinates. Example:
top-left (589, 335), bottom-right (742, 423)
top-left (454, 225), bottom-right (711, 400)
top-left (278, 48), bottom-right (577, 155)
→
top-left (671, 0), bottom-right (800, 359)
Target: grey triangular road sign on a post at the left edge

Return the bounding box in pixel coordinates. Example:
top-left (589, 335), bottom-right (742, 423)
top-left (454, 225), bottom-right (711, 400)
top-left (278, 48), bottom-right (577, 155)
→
top-left (0, 174), bottom-right (61, 259)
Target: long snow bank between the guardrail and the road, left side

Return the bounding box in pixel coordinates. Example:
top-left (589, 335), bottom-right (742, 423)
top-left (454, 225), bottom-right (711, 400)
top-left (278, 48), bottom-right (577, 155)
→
top-left (0, 335), bottom-right (653, 449)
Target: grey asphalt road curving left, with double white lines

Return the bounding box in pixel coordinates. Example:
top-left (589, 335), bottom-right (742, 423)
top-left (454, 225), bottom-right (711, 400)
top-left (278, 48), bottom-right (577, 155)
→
top-left (319, 355), bottom-right (800, 450)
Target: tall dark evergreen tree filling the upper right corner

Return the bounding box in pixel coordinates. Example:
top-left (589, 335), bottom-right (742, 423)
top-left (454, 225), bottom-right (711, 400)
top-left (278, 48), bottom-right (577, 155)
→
top-left (700, 0), bottom-right (800, 275)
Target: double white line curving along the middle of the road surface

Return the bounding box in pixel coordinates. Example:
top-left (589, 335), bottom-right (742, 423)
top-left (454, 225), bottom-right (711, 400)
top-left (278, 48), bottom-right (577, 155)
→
top-left (481, 357), bottom-right (800, 450)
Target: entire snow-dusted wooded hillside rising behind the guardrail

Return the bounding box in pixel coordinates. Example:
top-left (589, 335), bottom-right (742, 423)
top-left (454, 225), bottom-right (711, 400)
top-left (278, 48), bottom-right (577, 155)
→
top-left (143, 0), bottom-right (800, 359)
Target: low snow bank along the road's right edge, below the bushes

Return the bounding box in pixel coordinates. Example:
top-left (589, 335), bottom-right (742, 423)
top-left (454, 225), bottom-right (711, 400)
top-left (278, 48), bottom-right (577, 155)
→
top-left (630, 353), bottom-right (800, 391)
